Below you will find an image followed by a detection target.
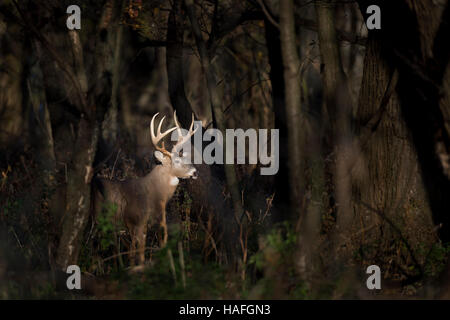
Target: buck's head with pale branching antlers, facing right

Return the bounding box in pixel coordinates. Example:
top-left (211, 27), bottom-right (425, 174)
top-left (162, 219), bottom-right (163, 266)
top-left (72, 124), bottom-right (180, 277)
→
top-left (150, 111), bottom-right (198, 179)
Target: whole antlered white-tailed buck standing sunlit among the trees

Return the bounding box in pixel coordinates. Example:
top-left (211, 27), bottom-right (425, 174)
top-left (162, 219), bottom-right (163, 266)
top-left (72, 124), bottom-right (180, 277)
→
top-left (93, 113), bottom-right (198, 265)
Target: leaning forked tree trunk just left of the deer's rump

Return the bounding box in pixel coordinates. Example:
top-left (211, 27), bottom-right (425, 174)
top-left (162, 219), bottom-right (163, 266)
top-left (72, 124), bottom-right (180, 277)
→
top-left (56, 0), bottom-right (115, 269)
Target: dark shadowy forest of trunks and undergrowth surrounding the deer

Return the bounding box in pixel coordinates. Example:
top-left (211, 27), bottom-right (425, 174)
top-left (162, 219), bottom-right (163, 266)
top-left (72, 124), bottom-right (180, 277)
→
top-left (0, 0), bottom-right (450, 299)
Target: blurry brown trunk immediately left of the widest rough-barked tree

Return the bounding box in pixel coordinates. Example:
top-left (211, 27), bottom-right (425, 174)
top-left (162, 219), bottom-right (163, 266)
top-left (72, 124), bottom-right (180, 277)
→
top-left (315, 0), bottom-right (354, 255)
